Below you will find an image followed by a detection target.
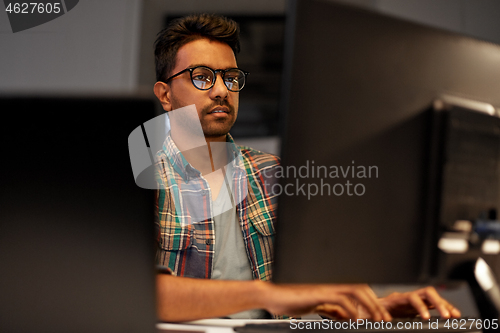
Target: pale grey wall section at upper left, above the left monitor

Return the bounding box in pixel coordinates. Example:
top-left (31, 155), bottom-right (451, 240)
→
top-left (0, 0), bottom-right (142, 94)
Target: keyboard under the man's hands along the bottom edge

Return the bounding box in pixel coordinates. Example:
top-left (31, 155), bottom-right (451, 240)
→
top-left (234, 317), bottom-right (484, 333)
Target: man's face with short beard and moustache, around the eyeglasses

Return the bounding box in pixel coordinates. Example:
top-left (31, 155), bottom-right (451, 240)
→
top-left (164, 39), bottom-right (239, 140)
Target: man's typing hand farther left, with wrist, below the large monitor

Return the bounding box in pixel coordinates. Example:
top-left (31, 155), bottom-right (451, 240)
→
top-left (266, 283), bottom-right (392, 321)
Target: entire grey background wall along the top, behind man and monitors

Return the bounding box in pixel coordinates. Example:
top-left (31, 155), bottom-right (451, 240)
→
top-left (0, 0), bottom-right (500, 94)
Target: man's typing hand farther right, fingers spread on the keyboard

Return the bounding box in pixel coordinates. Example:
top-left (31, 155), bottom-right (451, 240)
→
top-left (372, 287), bottom-right (460, 319)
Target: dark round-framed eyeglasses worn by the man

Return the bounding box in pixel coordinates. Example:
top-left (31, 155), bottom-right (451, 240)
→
top-left (165, 66), bottom-right (249, 92)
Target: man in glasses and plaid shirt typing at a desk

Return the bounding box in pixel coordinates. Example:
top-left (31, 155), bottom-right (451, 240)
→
top-left (154, 15), bottom-right (460, 321)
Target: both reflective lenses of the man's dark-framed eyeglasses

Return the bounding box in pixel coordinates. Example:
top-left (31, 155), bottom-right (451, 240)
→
top-left (191, 67), bottom-right (245, 91)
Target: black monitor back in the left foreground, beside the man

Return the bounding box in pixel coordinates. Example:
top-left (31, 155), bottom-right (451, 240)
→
top-left (0, 95), bottom-right (156, 332)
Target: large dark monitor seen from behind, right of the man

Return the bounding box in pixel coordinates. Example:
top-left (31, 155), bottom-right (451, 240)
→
top-left (273, 0), bottom-right (500, 283)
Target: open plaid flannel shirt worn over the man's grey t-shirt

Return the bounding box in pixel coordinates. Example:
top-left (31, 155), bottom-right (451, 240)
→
top-left (156, 134), bottom-right (279, 281)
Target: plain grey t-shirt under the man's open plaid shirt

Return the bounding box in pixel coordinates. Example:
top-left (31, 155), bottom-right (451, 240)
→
top-left (212, 163), bottom-right (267, 319)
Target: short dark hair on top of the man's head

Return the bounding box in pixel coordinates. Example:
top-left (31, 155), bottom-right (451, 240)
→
top-left (155, 14), bottom-right (240, 81)
